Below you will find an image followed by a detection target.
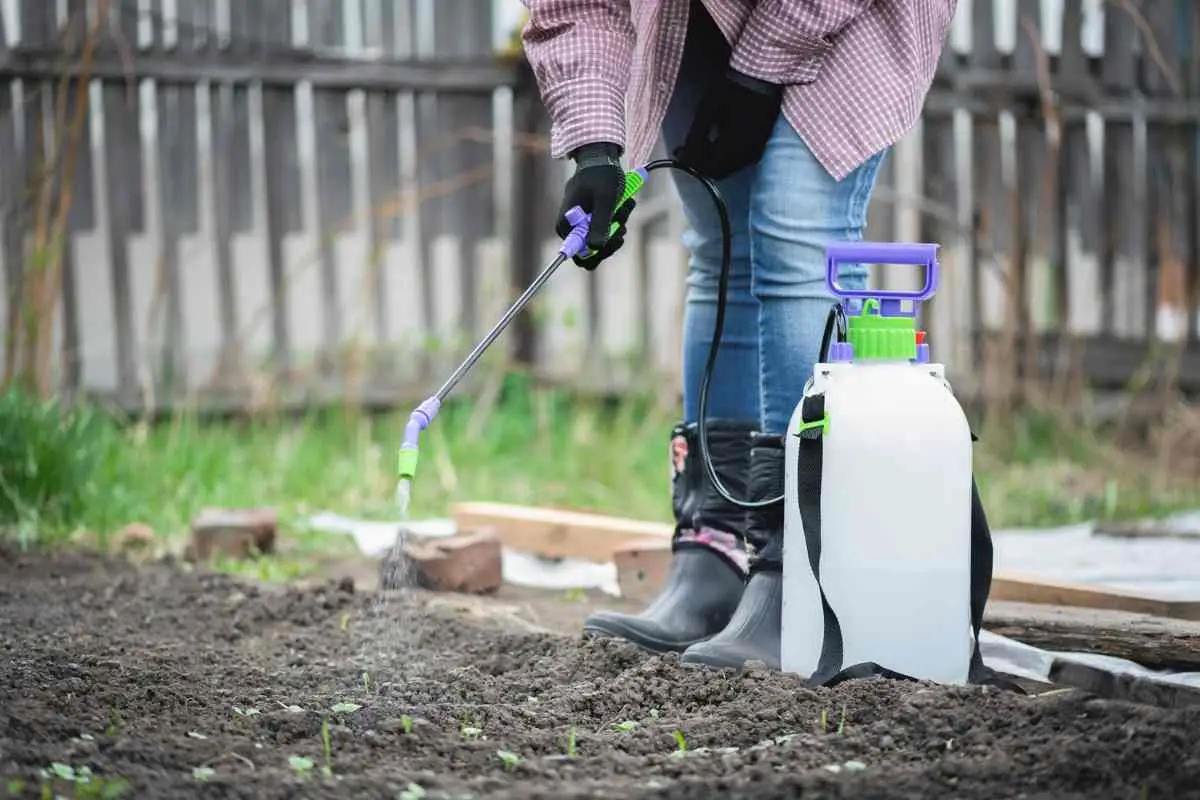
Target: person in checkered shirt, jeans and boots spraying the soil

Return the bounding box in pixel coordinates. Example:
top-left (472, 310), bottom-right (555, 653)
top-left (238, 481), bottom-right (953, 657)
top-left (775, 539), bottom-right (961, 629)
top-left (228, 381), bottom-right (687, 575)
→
top-left (521, 0), bottom-right (956, 669)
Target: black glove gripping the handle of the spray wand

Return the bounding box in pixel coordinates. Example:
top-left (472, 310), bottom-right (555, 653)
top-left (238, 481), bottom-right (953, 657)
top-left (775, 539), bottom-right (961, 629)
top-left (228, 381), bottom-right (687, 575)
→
top-left (554, 143), bottom-right (636, 270)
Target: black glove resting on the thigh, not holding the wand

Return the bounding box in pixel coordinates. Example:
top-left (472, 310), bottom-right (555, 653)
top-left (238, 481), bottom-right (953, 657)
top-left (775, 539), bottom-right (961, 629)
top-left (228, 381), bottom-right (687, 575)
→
top-left (674, 68), bottom-right (784, 180)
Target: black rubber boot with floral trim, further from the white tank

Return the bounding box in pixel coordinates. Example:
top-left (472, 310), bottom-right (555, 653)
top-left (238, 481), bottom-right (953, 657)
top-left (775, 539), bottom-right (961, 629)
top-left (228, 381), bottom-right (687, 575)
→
top-left (583, 420), bottom-right (755, 652)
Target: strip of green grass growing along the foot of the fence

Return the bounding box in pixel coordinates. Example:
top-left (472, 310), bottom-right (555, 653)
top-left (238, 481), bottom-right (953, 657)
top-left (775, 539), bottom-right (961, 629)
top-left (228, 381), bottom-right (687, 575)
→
top-left (0, 378), bottom-right (1200, 563)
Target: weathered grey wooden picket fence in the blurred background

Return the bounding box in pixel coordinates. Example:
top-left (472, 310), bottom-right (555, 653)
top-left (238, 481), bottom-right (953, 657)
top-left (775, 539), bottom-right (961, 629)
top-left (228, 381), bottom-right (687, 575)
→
top-left (0, 0), bottom-right (1200, 409)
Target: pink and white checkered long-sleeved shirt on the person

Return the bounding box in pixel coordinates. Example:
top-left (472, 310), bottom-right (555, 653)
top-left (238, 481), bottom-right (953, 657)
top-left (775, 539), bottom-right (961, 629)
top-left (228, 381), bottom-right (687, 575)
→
top-left (523, 0), bottom-right (958, 180)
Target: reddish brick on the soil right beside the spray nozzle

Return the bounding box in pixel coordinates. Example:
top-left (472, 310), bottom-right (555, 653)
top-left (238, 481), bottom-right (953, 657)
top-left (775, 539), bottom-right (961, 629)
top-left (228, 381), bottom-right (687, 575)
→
top-left (404, 530), bottom-right (504, 595)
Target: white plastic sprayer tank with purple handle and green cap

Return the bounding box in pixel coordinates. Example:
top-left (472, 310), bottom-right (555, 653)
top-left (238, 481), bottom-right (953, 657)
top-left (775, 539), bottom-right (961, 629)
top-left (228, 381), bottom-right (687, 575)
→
top-left (780, 242), bottom-right (973, 684)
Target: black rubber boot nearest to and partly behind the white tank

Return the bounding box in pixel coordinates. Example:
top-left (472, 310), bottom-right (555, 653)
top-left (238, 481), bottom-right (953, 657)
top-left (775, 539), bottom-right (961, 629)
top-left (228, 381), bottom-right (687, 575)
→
top-left (679, 434), bottom-right (784, 669)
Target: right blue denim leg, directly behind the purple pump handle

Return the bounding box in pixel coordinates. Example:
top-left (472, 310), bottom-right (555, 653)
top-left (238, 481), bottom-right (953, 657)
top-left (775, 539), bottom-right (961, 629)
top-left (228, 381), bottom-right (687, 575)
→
top-left (750, 118), bottom-right (887, 434)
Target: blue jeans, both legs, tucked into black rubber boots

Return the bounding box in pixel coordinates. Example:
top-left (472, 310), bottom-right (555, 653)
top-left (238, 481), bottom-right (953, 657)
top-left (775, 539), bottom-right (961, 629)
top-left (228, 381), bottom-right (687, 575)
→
top-left (662, 4), bottom-right (886, 434)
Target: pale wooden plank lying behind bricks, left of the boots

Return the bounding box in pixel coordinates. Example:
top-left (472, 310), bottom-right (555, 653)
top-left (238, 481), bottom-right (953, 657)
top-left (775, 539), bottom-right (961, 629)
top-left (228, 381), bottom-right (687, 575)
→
top-left (451, 503), bottom-right (674, 563)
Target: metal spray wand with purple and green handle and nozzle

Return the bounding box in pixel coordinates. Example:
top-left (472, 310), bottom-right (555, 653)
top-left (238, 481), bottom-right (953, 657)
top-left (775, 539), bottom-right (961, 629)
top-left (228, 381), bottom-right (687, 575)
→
top-left (396, 168), bottom-right (648, 481)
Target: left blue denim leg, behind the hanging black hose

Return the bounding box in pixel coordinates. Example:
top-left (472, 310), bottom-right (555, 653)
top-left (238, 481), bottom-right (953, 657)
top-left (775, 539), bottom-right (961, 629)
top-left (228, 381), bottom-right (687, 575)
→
top-left (662, 2), bottom-right (760, 422)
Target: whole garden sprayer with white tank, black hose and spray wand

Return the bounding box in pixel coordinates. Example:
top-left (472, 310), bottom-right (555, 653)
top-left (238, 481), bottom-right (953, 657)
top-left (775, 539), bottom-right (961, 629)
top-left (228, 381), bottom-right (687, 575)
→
top-left (384, 158), bottom-right (991, 684)
